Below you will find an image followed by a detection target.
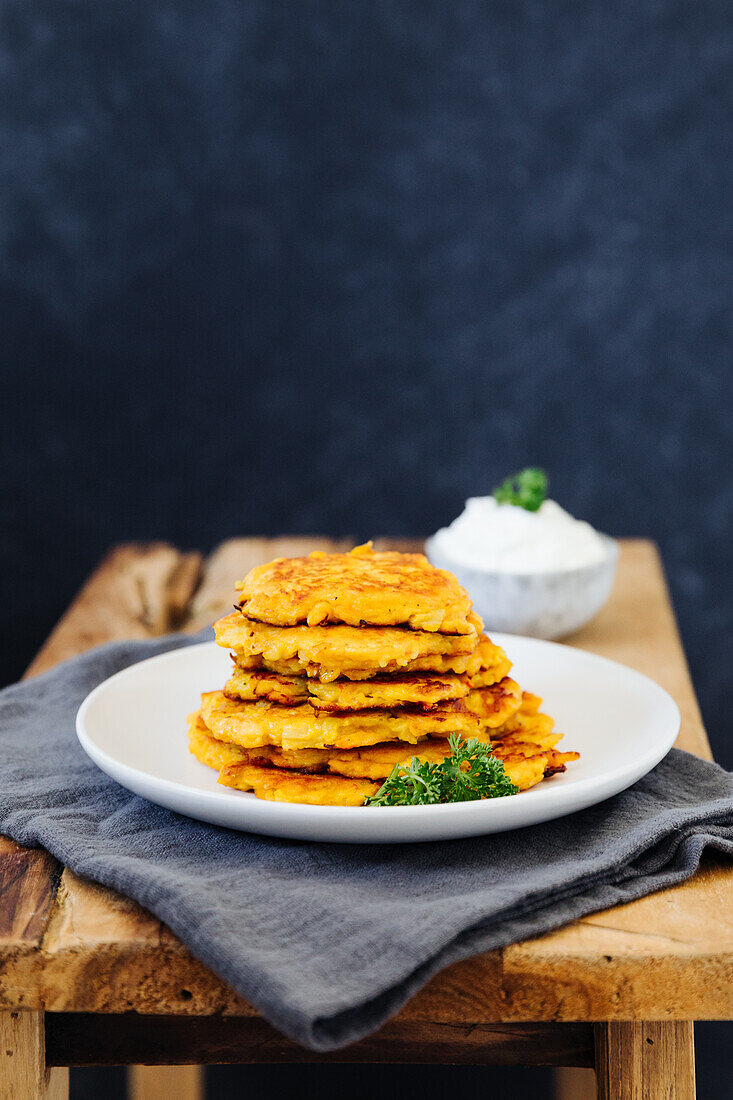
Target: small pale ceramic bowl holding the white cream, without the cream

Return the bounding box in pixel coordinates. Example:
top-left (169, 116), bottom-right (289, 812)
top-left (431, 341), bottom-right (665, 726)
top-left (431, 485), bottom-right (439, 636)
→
top-left (425, 531), bottom-right (619, 639)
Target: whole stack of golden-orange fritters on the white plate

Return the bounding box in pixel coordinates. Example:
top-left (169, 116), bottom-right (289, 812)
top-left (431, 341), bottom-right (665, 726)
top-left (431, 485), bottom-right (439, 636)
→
top-left (189, 543), bottom-right (578, 806)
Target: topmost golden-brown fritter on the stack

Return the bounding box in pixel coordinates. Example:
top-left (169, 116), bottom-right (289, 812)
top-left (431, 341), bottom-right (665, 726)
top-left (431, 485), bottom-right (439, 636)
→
top-left (237, 543), bottom-right (474, 635)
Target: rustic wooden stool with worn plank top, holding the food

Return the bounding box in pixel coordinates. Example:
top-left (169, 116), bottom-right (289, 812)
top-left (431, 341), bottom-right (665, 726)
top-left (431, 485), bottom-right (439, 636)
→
top-left (0, 538), bottom-right (733, 1100)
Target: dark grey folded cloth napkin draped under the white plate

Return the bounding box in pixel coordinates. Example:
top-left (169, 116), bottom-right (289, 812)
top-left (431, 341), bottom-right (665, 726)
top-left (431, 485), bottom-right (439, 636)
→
top-left (0, 636), bottom-right (733, 1051)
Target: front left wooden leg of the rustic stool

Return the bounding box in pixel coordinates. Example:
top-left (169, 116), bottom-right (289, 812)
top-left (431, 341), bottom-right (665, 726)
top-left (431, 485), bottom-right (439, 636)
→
top-left (0, 1010), bottom-right (68, 1100)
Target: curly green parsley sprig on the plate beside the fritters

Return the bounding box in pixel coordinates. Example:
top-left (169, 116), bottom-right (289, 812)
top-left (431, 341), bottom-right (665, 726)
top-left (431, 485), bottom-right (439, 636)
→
top-left (367, 734), bottom-right (518, 806)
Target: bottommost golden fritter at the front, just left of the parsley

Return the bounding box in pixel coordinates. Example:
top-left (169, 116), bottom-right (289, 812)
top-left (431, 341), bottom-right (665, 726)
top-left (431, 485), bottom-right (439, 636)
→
top-left (219, 763), bottom-right (380, 806)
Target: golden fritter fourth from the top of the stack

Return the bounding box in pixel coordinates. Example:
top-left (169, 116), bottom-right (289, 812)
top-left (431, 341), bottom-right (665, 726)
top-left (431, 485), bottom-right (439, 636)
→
top-left (201, 689), bottom-right (473, 749)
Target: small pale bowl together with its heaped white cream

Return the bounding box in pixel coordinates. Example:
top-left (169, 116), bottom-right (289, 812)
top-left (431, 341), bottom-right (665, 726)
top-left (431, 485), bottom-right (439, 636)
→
top-left (426, 477), bottom-right (619, 638)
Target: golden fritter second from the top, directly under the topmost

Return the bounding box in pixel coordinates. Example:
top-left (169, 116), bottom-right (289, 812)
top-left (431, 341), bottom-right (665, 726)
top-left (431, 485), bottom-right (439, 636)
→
top-left (214, 612), bottom-right (481, 682)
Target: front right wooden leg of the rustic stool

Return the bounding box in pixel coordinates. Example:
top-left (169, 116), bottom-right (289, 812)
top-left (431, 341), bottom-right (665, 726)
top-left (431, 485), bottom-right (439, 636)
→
top-left (594, 1020), bottom-right (694, 1100)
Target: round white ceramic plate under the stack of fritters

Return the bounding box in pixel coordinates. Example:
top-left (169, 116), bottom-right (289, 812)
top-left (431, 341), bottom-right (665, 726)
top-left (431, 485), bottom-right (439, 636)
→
top-left (77, 634), bottom-right (680, 844)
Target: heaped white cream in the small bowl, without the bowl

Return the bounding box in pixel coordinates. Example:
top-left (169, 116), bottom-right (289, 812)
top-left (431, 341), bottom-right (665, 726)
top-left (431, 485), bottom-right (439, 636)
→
top-left (436, 496), bottom-right (609, 573)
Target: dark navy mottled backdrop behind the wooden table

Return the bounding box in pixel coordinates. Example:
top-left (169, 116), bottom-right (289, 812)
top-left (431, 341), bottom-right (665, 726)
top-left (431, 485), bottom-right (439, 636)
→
top-left (0, 0), bottom-right (733, 1096)
